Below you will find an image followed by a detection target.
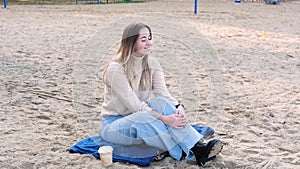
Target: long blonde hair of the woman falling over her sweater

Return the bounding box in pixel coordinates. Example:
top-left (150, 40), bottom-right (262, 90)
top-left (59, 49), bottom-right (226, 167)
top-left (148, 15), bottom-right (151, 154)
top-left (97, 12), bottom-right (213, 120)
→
top-left (103, 23), bottom-right (152, 90)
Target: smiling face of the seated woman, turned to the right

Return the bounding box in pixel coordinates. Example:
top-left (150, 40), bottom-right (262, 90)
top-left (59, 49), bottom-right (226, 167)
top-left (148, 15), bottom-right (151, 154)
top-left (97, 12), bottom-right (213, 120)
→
top-left (134, 28), bottom-right (152, 56)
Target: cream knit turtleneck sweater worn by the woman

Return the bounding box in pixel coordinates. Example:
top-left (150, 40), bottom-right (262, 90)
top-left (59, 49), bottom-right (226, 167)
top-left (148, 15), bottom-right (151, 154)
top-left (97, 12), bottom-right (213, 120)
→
top-left (102, 57), bottom-right (178, 116)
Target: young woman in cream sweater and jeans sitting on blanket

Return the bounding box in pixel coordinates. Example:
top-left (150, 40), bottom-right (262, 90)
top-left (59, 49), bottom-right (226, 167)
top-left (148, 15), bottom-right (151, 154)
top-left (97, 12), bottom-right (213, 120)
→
top-left (101, 23), bottom-right (223, 166)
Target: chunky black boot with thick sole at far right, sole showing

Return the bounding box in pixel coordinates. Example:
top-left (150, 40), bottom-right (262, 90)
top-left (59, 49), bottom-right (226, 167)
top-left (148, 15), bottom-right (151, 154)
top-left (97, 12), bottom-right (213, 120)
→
top-left (191, 139), bottom-right (223, 166)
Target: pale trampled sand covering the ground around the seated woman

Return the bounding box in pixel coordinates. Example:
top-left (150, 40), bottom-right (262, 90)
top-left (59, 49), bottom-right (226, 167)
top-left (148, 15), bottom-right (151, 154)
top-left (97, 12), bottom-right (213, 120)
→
top-left (0, 0), bottom-right (300, 169)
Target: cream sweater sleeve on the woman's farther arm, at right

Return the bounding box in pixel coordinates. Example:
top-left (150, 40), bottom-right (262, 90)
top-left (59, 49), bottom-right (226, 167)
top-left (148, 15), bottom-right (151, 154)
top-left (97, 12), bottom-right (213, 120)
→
top-left (151, 60), bottom-right (178, 105)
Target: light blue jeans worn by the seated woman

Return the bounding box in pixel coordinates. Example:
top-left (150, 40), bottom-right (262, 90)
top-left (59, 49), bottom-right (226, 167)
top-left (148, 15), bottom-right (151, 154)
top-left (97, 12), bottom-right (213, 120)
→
top-left (101, 97), bottom-right (203, 161)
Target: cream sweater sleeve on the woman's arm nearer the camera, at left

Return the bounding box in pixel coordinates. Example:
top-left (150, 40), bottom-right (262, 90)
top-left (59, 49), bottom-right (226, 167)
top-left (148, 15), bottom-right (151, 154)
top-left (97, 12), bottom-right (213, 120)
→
top-left (106, 62), bottom-right (152, 112)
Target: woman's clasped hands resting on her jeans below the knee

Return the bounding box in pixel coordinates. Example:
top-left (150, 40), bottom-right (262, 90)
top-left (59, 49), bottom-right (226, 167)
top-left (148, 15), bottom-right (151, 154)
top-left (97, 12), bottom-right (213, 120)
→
top-left (160, 113), bottom-right (187, 129)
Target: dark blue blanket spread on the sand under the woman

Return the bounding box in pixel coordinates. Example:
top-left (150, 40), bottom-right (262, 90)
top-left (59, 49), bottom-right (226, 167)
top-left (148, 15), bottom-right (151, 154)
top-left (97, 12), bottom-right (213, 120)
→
top-left (68, 125), bottom-right (214, 167)
